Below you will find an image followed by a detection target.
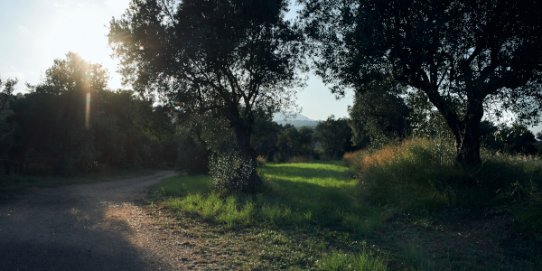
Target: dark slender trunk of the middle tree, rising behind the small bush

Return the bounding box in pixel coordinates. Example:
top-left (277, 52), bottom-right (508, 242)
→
top-left (233, 124), bottom-right (262, 193)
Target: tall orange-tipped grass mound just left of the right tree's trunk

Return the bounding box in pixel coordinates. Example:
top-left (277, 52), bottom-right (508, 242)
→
top-left (350, 140), bottom-right (458, 209)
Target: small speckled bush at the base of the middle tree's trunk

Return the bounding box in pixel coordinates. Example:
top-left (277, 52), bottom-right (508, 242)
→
top-left (209, 151), bottom-right (256, 193)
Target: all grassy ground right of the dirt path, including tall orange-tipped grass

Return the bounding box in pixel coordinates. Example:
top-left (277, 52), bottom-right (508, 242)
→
top-left (151, 141), bottom-right (542, 270)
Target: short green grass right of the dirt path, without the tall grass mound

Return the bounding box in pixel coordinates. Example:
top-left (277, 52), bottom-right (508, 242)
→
top-left (151, 162), bottom-right (541, 270)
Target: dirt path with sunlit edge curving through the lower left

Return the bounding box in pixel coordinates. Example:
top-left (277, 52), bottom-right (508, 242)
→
top-left (0, 171), bottom-right (179, 270)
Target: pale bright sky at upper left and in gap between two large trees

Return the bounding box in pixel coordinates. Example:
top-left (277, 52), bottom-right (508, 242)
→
top-left (0, 0), bottom-right (352, 120)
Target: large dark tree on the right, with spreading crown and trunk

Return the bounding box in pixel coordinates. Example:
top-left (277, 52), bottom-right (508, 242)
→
top-left (301, 0), bottom-right (542, 166)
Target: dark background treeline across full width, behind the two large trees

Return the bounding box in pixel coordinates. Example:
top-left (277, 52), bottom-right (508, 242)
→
top-left (0, 53), bottom-right (542, 175)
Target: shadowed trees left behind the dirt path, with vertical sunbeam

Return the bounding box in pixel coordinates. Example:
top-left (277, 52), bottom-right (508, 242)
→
top-left (0, 53), bottom-right (176, 175)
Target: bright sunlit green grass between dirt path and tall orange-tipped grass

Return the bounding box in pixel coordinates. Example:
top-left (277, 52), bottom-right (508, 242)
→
top-left (154, 163), bottom-right (382, 232)
